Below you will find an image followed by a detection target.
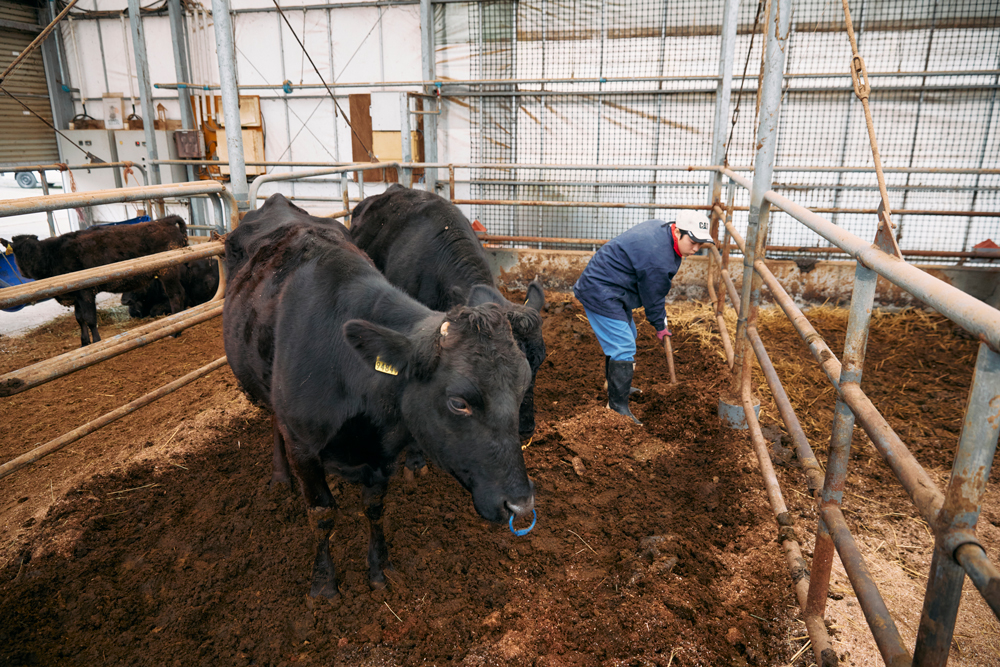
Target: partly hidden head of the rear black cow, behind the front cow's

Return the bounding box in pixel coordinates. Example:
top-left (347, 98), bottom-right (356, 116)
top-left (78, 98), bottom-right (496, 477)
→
top-left (468, 278), bottom-right (545, 441)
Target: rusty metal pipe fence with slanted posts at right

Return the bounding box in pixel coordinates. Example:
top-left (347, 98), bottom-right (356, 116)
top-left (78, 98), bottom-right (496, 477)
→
top-left (709, 164), bottom-right (1000, 665)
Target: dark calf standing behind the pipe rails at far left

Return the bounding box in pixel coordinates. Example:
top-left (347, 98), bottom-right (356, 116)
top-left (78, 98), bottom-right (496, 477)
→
top-left (5, 215), bottom-right (188, 347)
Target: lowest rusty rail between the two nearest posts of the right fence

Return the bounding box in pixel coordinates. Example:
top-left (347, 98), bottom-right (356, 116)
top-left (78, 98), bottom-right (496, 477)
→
top-left (820, 505), bottom-right (911, 667)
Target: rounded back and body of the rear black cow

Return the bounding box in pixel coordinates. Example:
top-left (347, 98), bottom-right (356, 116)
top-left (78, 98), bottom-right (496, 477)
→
top-left (351, 184), bottom-right (494, 310)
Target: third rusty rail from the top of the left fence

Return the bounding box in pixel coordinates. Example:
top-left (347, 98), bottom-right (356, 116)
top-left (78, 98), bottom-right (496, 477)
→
top-left (0, 300), bottom-right (222, 397)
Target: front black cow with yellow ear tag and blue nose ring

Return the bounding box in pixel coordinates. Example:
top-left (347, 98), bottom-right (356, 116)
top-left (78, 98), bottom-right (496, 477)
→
top-left (223, 200), bottom-right (534, 597)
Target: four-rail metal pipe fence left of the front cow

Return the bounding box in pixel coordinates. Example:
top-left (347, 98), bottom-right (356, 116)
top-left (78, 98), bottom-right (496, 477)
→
top-left (0, 181), bottom-right (232, 478)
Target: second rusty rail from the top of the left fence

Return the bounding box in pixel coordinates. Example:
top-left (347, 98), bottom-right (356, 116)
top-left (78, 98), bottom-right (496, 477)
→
top-left (0, 241), bottom-right (225, 308)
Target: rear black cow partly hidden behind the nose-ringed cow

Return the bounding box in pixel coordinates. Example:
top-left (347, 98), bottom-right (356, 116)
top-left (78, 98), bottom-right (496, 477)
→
top-left (351, 184), bottom-right (545, 440)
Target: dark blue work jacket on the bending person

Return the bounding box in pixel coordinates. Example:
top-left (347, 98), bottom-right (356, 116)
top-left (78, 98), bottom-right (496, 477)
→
top-left (573, 220), bottom-right (682, 331)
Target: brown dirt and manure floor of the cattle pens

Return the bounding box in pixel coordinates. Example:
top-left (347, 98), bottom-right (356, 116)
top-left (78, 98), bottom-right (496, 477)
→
top-left (0, 294), bottom-right (1000, 667)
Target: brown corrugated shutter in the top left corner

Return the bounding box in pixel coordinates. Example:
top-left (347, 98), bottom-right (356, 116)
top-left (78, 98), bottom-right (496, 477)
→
top-left (0, 0), bottom-right (59, 164)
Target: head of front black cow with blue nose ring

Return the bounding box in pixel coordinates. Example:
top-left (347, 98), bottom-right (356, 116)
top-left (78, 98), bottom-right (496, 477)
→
top-left (344, 304), bottom-right (534, 521)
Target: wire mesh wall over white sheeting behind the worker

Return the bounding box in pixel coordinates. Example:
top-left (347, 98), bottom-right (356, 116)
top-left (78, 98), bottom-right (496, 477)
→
top-left (438, 0), bottom-right (1000, 264)
